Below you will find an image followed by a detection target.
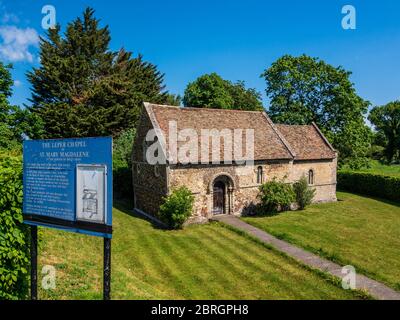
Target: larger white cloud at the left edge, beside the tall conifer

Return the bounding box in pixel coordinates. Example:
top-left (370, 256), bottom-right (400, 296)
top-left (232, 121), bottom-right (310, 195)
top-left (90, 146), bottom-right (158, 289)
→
top-left (0, 26), bottom-right (39, 62)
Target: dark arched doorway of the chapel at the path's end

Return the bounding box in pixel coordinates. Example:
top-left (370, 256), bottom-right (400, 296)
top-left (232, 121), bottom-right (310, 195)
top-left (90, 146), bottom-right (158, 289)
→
top-left (212, 175), bottom-right (233, 215)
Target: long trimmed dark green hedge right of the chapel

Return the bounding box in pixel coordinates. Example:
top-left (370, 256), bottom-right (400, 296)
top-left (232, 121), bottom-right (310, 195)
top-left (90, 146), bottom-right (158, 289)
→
top-left (337, 171), bottom-right (400, 201)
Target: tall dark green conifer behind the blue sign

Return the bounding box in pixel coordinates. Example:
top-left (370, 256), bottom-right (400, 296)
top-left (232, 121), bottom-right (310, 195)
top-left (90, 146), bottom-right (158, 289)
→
top-left (28, 8), bottom-right (167, 138)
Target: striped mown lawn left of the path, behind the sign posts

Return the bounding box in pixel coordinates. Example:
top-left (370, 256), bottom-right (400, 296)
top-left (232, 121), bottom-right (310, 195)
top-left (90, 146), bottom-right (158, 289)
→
top-left (39, 205), bottom-right (357, 299)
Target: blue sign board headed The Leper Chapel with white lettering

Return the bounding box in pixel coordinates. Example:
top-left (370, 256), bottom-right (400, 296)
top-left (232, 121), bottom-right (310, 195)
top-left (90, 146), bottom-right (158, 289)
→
top-left (23, 137), bottom-right (112, 238)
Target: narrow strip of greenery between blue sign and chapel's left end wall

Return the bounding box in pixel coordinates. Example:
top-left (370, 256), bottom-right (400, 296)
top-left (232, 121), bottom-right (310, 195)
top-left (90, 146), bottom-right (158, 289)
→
top-left (113, 128), bottom-right (136, 199)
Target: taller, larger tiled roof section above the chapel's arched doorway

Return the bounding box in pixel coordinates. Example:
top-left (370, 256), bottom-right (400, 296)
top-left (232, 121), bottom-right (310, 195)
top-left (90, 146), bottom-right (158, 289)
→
top-left (145, 103), bottom-right (294, 161)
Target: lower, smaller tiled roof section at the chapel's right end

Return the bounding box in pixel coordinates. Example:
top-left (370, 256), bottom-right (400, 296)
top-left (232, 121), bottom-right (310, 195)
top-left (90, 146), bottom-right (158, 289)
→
top-left (275, 124), bottom-right (336, 160)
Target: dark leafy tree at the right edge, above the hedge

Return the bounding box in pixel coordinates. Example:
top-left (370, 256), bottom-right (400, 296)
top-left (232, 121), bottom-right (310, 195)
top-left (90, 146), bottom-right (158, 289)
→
top-left (368, 101), bottom-right (400, 162)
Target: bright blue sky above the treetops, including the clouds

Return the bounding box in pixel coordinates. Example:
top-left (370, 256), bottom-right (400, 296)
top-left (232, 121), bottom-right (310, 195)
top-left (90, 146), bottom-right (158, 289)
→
top-left (0, 0), bottom-right (400, 106)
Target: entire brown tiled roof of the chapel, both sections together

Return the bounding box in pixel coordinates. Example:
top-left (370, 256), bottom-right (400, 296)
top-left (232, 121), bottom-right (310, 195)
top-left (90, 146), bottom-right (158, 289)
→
top-left (145, 103), bottom-right (336, 162)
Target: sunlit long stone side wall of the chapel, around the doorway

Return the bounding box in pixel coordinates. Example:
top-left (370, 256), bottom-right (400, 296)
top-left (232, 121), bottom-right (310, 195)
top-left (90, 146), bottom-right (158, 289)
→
top-left (168, 159), bottom-right (336, 222)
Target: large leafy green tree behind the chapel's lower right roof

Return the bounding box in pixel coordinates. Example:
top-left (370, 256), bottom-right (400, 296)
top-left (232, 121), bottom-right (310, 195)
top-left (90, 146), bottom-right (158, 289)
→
top-left (261, 55), bottom-right (371, 168)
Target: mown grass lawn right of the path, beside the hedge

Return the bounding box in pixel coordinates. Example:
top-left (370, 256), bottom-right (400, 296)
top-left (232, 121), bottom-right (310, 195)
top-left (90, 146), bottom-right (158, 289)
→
top-left (243, 192), bottom-right (400, 290)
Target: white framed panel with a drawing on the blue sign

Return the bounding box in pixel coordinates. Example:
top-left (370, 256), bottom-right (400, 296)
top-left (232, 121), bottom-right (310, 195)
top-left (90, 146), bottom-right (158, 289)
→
top-left (76, 165), bottom-right (106, 223)
